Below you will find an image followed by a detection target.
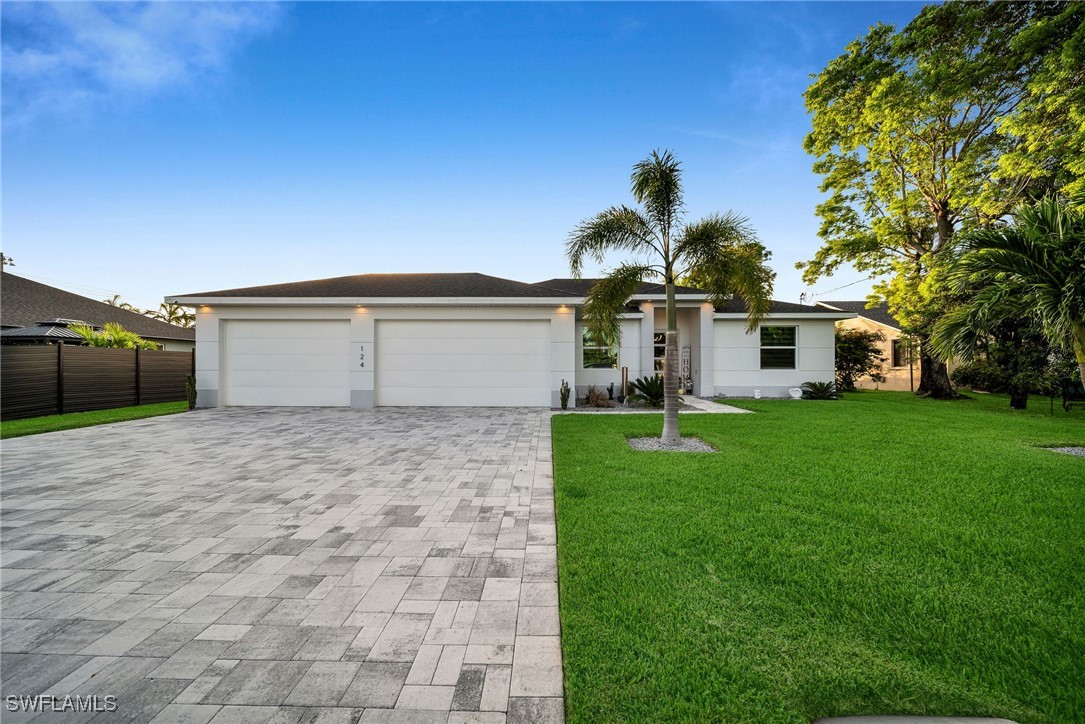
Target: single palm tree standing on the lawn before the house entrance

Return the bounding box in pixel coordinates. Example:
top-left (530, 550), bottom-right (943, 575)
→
top-left (565, 151), bottom-right (776, 445)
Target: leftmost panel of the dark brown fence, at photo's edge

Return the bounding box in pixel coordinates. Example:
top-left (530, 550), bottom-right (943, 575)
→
top-left (0, 345), bottom-right (56, 420)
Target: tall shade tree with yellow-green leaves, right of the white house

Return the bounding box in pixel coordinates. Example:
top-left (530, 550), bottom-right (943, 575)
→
top-left (800, 2), bottom-right (1073, 397)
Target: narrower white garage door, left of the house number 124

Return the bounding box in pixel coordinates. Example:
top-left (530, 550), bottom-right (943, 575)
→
top-left (225, 319), bottom-right (350, 407)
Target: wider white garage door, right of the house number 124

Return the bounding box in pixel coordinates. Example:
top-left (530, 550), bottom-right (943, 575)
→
top-left (375, 320), bottom-right (550, 407)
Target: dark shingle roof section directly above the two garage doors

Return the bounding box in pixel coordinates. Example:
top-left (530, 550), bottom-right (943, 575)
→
top-left (177, 272), bottom-right (576, 299)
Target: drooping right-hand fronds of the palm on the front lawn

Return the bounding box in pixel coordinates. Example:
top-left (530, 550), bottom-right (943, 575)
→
top-left (675, 213), bottom-right (776, 332)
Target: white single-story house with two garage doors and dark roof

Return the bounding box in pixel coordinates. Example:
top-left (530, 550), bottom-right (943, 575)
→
top-left (166, 274), bottom-right (855, 407)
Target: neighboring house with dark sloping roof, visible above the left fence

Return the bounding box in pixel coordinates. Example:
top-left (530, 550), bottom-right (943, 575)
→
top-left (0, 271), bottom-right (195, 352)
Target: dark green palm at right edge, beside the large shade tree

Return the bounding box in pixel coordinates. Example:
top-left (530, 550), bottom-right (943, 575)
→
top-left (934, 192), bottom-right (1085, 383)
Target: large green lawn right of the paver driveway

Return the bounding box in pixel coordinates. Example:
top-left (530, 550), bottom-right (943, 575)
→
top-left (553, 392), bottom-right (1085, 723)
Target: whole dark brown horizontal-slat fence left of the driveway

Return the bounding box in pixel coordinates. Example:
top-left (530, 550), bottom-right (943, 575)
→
top-left (0, 344), bottom-right (195, 420)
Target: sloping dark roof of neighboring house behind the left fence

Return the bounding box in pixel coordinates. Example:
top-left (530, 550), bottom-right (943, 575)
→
top-left (0, 271), bottom-right (196, 341)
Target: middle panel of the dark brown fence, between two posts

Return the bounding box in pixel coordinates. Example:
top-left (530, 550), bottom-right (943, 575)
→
top-left (64, 346), bottom-right (136, 412)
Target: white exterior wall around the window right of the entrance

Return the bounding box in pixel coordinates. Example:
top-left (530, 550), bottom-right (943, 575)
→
top-left (713, 317), bottom-right (837, 397)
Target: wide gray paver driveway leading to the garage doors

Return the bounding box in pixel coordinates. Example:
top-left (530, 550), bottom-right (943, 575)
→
top-left (6, 408), bottom-right (563, 724)
